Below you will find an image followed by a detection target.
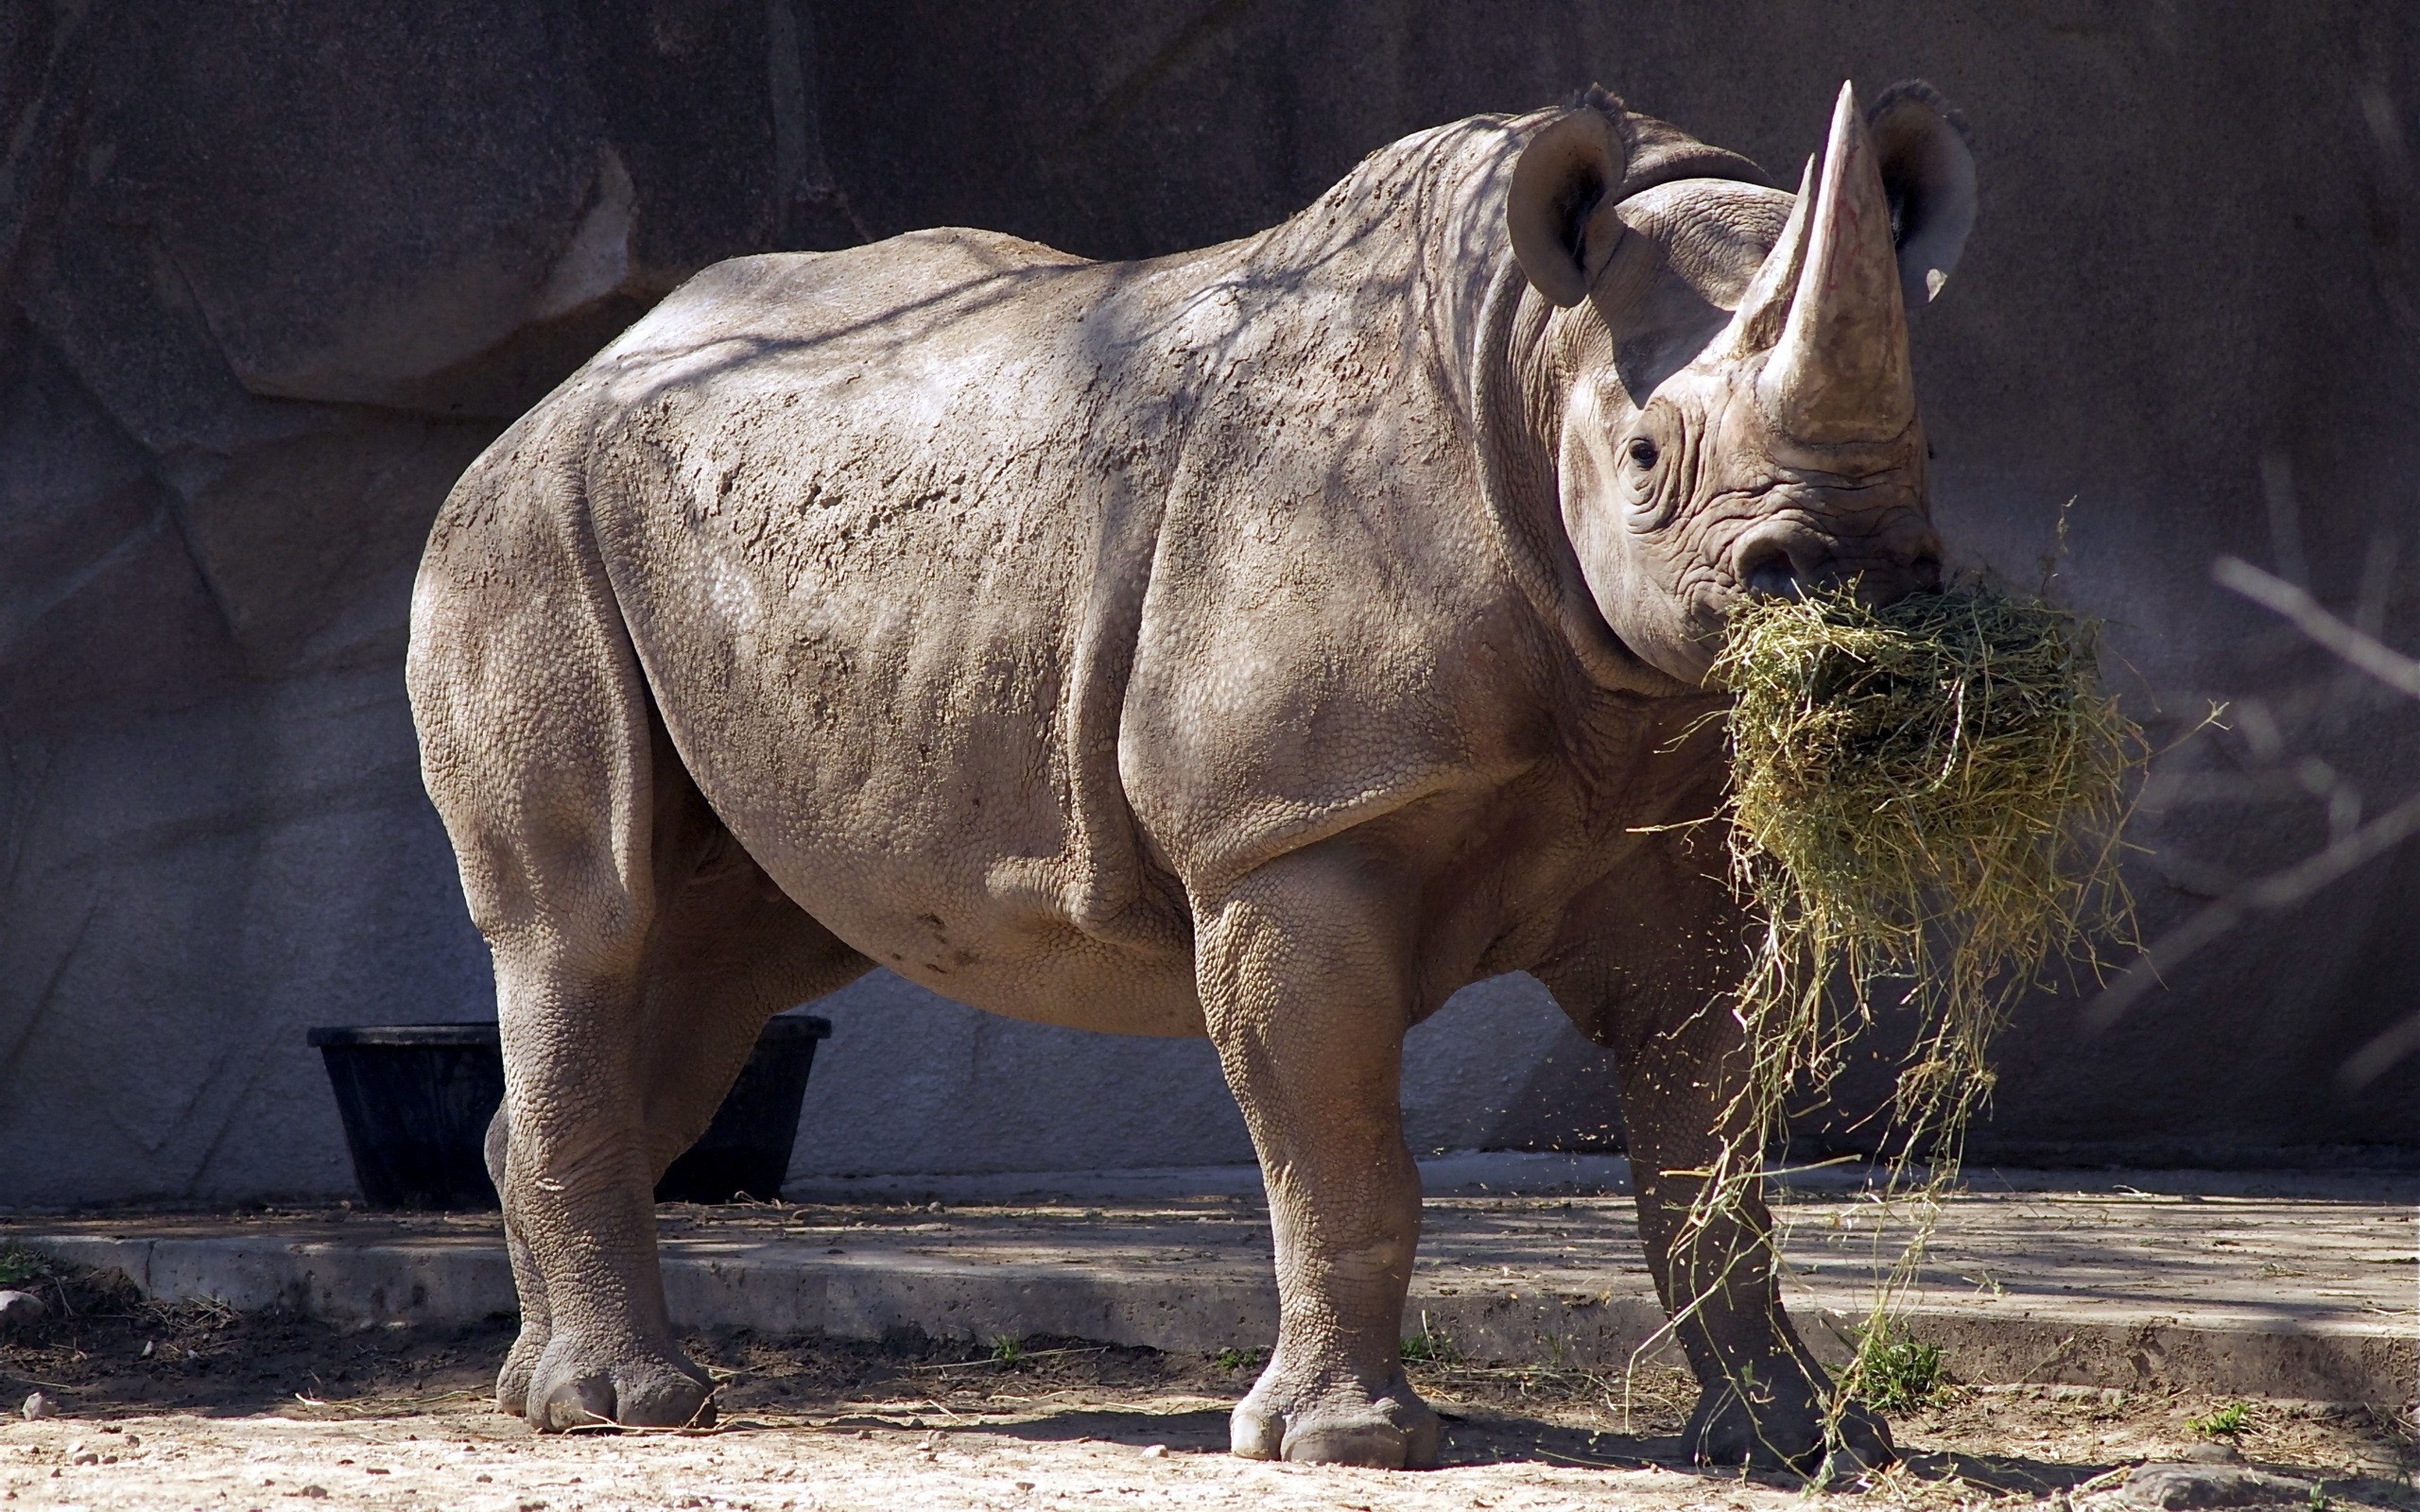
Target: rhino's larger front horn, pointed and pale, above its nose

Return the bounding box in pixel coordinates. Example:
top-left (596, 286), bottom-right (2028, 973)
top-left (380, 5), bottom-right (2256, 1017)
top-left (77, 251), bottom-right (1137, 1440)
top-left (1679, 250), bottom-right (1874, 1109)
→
top-left (1757, 85), bottom-right (1917, 445)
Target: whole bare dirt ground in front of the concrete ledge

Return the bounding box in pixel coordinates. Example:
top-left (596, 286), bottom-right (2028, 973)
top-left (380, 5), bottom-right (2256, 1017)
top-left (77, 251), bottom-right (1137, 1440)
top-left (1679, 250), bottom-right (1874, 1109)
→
top-left (0, 1247), bottom-right (2415, 1512)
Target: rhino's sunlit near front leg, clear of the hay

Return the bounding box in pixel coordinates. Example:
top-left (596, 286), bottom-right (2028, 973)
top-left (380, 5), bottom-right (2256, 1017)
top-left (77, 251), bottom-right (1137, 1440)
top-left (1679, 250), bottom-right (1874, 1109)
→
top-left (1196, 854), bottom-right (1438, 1469)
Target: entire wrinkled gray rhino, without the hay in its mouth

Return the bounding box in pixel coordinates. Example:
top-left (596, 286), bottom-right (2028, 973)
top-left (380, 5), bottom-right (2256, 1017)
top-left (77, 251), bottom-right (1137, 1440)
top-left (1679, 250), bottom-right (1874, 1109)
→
top-left (409, 77), bottom-right (1972, 1466)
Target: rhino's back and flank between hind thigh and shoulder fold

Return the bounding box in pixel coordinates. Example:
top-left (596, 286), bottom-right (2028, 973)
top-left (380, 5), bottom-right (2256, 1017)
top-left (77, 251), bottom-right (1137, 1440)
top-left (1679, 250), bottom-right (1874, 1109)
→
top-left (579, 232), bottom-right (1219, 1033)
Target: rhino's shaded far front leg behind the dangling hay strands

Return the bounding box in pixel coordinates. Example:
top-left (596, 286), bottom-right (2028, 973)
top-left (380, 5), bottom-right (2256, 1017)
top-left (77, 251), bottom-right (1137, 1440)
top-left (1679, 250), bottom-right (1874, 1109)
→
top-left (1619, 1002), bottom-right (1893, 1470)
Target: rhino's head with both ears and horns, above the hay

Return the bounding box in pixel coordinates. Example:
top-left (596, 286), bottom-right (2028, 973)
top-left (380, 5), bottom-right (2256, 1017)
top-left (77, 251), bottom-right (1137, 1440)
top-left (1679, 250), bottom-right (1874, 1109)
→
top-left (1508, 85), bottom-right (1975, 684)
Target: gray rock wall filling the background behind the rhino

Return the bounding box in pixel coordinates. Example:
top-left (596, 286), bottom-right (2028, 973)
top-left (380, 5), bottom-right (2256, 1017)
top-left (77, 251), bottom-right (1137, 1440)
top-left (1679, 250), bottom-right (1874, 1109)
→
top-left (0, 0), bottom-right (2420, 1200)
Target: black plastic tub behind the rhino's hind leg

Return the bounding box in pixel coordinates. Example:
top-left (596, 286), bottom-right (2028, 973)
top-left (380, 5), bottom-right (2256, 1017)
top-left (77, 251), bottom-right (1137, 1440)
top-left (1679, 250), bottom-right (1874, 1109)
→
top-left (307, 1014), bottom-right (833, 1210)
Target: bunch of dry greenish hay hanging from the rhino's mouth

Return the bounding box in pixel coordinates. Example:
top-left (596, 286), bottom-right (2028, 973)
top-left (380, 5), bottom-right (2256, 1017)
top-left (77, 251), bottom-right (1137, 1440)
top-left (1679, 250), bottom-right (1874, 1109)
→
top-left (1697, 586), bottom-right (2144, 1452)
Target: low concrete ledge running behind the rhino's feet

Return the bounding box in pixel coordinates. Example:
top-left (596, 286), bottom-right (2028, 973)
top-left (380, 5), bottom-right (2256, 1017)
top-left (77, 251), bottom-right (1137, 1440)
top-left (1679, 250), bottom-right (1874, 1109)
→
top-left (5, 1180), bottom-right (2420, 1413)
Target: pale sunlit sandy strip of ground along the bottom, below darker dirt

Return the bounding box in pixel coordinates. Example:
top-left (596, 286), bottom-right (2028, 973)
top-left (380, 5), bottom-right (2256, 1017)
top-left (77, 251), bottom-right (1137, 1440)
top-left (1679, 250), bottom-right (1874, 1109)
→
top-left (0, 1388), bottom-right (2412, 1512)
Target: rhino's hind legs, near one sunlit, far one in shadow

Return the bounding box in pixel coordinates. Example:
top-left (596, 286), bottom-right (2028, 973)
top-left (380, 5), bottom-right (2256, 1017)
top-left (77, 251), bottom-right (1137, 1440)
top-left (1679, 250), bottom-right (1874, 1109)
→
top-left (409, 467), bottom-right (864, 1427)
